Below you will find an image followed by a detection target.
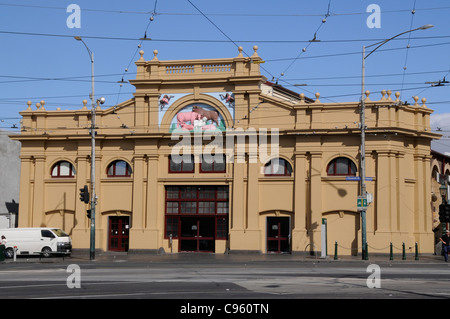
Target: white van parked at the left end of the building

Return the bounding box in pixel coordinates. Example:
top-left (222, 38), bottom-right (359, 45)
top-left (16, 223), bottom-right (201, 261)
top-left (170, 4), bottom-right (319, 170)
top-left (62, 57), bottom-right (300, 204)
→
top-left (0, 227), bottom-right (72, 258)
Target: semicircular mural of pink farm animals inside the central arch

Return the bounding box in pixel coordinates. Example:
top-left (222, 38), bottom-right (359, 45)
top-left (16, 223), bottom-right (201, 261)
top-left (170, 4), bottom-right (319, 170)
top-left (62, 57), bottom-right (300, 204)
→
top-left (169, 103), bottom-right (226, 132)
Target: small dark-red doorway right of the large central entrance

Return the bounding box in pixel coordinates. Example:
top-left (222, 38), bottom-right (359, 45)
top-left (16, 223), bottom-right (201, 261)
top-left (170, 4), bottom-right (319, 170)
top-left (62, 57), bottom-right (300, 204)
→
top-left (267, 217), bottom-right (291, 253)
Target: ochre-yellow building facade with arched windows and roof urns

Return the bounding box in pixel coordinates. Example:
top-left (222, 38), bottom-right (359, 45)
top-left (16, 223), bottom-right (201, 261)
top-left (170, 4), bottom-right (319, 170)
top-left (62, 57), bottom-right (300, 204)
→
top-left (12, 47), bottom-right (439, 255)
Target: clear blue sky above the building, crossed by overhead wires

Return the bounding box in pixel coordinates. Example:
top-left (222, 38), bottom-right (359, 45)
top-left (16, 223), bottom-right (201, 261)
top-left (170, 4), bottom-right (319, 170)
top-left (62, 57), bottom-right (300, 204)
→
top-left (0, 0), bottom-right (450, 151)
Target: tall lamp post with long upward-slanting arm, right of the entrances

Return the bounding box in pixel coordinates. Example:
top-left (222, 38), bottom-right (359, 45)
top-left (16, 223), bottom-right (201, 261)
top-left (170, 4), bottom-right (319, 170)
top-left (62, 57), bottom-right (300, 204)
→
top-left (360, 24), bottom-right (433, 260)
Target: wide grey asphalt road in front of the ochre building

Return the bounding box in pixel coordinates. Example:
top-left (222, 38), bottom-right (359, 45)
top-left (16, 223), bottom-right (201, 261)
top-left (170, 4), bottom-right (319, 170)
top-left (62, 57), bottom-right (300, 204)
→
top-left (0, 254), bottom-right (450, 304)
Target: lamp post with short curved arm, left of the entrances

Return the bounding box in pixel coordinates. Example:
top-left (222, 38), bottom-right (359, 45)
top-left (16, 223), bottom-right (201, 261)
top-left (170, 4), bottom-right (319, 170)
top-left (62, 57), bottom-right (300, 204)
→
top-left (74, 36), bottom-right (105, 260)
